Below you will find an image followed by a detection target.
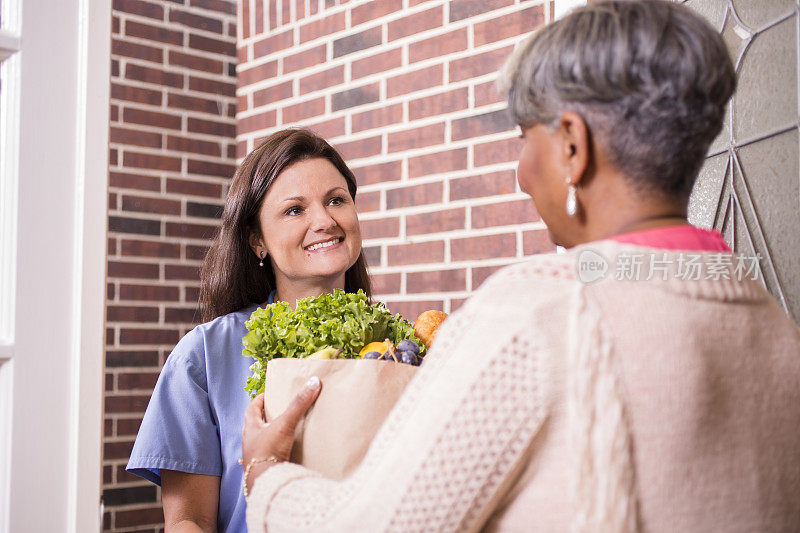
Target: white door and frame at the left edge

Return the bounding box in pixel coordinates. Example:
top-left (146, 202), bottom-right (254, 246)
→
top-left (0, 0), bottom-right (111, 532)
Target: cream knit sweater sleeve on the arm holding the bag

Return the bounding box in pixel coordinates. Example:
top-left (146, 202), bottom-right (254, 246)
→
top-left (247, 264), bottom-right (546, 532)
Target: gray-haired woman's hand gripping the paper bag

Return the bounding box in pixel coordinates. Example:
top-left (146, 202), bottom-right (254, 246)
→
top-left (242, 376), bottom-right (321, 494)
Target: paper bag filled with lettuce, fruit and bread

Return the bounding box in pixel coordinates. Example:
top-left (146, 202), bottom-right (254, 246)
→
top-left (242, 289), bottom-right (447, 479)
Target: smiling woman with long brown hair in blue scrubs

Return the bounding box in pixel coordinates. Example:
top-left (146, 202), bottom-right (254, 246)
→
top-left (127, 129), bottom-right (370, 532)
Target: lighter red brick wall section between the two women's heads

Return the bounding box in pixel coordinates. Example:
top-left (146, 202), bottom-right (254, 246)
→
top-left (236, 0), bottom-right (553, 320)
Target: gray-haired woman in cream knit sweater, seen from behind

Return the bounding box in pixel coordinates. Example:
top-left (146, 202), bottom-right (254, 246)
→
top-left (243, 0), bottom-right (800, 532)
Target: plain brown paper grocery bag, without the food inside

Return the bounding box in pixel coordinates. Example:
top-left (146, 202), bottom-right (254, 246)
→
top-left (264, 358), bottom-right (417, 480)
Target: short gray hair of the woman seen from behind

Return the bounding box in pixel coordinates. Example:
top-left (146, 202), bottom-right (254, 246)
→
top-left (499, 0), bottom-right (736, 200)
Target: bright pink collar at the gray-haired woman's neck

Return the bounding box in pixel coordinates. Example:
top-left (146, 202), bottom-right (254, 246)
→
top-left (609, 224), bottom-right (731, 252)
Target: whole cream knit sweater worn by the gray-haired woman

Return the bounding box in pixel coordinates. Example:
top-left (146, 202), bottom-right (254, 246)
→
top-left (247, 241), bottom-right (800, 532)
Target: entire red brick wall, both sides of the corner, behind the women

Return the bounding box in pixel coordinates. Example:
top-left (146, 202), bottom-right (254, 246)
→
top-left (103, 0), bottom-right (553, 531)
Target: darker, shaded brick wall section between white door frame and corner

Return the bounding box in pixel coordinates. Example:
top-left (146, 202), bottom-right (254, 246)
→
top-left (103, 0), bottom-right (236, 531)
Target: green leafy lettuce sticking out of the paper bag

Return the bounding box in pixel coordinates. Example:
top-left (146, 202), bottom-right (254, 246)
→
top-left (242, 289), bottom-right (425, 397)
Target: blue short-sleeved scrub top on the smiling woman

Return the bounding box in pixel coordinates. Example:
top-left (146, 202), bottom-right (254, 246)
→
top-left (126, 291), bottom-right (275, 533)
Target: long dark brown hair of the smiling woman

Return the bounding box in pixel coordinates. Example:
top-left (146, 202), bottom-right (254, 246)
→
top-left (200, 129), bottom-right (371, 322)
